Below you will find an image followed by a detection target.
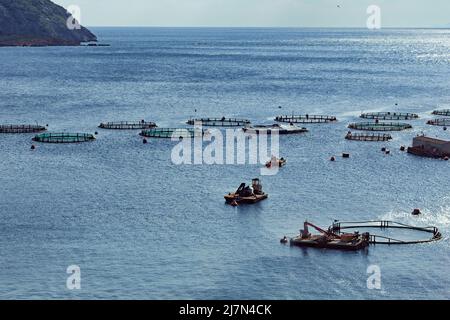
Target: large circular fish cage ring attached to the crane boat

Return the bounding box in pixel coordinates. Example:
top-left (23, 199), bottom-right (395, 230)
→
top-left (330, 221), bottom-right (442, 245)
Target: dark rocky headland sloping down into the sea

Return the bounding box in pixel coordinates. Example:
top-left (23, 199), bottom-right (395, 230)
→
top-left (0, 0), bottom-right (97, 46)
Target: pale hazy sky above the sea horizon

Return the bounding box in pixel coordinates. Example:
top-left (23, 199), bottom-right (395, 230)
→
top-left (53, 0), bottom-right (450, 27)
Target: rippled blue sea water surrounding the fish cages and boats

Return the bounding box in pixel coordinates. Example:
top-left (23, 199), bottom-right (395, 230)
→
top-left (0, 28), bottom-right (450, 299)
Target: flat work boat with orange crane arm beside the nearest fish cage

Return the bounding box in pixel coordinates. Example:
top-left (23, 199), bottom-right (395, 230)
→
top-left (290, 221), bottom-right (370, 251)
